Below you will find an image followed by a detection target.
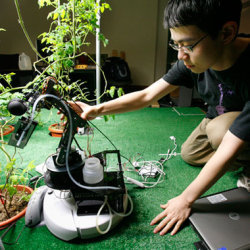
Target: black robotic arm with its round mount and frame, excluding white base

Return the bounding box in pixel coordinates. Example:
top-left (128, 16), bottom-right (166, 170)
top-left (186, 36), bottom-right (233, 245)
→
top-left (8, 77), bottom-right (125, 194)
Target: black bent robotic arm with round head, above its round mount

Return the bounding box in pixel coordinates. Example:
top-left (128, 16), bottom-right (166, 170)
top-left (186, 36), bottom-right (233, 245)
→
top-left (8, 77), bottom-right (88, 166)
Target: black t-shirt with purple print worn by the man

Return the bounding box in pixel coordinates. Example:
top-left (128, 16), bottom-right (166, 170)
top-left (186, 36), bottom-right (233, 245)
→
top-left (163, 45), bottom-right (250, 141)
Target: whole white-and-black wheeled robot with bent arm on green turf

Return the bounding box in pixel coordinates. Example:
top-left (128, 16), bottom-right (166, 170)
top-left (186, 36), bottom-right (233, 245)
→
top-left (8, 77), bottom-right (132, 241)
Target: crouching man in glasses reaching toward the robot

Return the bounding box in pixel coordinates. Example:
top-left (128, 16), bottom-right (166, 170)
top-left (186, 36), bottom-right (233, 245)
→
top-left (72, 0), bottom-right (250, 235)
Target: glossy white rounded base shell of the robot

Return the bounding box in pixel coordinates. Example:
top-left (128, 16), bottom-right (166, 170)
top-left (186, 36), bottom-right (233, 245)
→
top-left (43, 189), bottom-right (128, 241)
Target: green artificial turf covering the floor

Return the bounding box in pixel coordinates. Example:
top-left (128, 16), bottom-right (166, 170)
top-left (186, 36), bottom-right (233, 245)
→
top-left (0, 108), bottom-right (240, 249)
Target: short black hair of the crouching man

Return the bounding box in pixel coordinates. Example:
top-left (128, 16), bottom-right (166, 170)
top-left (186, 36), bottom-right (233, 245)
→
top-left (164, 0), bottom-right (242, 38)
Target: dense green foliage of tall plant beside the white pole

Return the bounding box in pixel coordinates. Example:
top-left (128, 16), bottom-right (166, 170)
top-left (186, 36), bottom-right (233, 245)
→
top-left (34, 0), bottom-right (110, 100)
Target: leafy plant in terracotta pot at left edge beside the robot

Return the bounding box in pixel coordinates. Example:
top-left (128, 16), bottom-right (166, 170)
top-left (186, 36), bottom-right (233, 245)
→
top-left (0, 73), bottom-right (34, 229)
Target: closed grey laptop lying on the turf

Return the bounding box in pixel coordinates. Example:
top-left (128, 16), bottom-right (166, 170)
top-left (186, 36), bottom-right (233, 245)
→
top-left (189, 188), bottom-right (250, 250)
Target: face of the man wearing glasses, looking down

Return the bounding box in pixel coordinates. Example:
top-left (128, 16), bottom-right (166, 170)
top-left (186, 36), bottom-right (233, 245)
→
top-left (170, 25), bottom-right (222, 73)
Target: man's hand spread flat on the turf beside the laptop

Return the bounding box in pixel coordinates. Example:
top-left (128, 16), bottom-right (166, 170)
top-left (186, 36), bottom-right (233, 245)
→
top-left (150, 195), bottom-right (191, 235)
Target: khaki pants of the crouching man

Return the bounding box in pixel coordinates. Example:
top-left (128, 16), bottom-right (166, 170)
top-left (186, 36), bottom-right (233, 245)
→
top-left (181, 112), bottom-right (250, 170)
